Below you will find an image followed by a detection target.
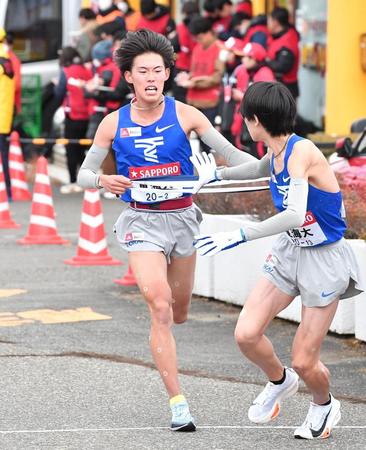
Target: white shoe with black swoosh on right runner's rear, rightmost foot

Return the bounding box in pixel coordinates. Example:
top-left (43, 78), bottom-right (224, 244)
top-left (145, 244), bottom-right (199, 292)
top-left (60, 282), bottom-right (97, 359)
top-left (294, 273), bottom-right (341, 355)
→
top-left (294, 394), bottom-right (341, 439)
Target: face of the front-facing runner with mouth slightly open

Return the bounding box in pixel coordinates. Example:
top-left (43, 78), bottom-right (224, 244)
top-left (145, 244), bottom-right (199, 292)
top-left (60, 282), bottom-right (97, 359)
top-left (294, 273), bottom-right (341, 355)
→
top-left (125, 53), bottom-right (170, 104)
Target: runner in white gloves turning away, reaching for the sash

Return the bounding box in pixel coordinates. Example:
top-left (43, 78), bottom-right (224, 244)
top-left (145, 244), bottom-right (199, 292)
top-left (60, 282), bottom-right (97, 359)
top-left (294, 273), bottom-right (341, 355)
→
top-left (195, 82), bottom-right (362, 439)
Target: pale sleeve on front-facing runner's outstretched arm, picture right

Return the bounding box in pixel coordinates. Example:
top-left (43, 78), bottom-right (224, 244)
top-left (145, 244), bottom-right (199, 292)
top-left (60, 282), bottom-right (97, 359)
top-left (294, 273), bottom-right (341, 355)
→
top-left (200, 127), bottom-right (257, 166)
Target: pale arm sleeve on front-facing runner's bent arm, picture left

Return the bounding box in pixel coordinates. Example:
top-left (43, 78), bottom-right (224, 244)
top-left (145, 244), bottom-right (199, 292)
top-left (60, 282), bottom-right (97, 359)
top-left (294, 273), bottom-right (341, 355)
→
top-left (77, 144), bottom-right (109, 189)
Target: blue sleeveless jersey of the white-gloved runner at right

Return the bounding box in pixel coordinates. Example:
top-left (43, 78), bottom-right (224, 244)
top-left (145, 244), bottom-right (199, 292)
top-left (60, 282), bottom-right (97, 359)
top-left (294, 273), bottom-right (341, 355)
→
top-left (269, 134), bottom-right (347, 247)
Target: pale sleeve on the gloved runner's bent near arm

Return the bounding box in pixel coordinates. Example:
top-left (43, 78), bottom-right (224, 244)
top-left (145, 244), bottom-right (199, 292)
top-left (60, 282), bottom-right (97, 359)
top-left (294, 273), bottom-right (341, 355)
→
top-left (243, 178), bottom-right (309, 241)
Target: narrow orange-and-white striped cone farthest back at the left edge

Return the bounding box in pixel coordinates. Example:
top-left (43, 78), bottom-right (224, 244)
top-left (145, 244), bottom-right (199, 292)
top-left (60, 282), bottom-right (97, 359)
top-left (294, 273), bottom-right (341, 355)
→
top-left (9, 131), bottom-right (32, 201)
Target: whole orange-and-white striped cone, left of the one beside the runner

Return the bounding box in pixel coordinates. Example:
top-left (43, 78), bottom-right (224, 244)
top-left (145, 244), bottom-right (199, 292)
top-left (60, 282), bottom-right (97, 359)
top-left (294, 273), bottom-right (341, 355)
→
top-left (17, 156), bottom-right (69, 244)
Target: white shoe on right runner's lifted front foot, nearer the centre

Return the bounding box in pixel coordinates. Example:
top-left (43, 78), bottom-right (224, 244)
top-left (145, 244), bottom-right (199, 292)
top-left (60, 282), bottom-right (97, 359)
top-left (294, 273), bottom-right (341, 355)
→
top-left (248, 367), bottom-right (299, 423)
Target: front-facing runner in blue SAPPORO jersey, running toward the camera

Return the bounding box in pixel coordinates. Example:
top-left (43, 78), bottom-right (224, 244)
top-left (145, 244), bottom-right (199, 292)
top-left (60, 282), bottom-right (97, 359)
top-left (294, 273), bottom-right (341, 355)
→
top-left (78, 30), bottom-right (254, 431)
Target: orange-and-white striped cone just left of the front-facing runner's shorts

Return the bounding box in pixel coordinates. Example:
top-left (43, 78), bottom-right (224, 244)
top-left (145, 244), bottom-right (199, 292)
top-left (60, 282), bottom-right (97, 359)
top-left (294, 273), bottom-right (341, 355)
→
top-left (64, 189), bottom-right (121, 266)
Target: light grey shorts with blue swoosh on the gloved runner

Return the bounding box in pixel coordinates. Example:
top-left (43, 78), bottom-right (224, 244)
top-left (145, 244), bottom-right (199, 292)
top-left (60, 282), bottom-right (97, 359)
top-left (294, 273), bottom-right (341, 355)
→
top-left (263, 234), bottom-right (363, 307)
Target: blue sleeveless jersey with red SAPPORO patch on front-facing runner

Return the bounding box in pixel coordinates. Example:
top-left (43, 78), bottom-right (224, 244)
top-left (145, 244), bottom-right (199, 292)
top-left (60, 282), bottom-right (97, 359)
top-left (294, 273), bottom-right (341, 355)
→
top-left (112, 96), bottom-right (194, 202)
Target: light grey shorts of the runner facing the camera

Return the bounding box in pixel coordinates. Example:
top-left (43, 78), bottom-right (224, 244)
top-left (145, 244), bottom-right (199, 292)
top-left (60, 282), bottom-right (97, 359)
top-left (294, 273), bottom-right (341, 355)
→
top-left (113, 204), bottom-right (202, 263)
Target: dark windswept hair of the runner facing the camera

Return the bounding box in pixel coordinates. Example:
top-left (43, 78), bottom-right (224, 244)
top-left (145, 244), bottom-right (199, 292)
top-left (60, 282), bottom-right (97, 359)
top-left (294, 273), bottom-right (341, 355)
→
top-left (114, 28), bottom-right (174, 74)
